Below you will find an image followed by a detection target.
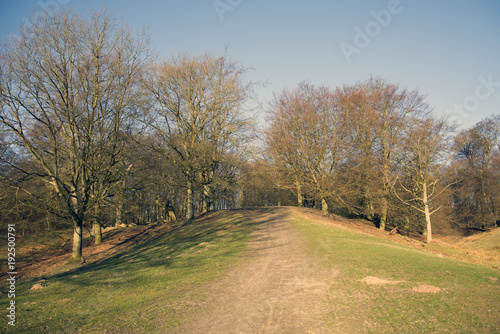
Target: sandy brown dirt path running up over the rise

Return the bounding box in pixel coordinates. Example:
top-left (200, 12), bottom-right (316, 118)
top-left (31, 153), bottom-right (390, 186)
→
top-left (183, 208), bottom-right (336, 334)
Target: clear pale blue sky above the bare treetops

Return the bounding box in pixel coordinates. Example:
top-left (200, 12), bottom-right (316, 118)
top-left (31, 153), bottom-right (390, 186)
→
top-left (0, 0), bottom-right (500, 128)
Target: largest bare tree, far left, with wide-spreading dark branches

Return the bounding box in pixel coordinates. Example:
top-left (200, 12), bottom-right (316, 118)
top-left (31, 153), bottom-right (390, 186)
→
top-left (0, 12), bottom-right (147, 259)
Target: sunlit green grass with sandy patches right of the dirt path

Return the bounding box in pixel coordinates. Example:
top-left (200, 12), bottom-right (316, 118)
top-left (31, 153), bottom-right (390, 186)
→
top-left (294, 216), bottom-right (500, 333)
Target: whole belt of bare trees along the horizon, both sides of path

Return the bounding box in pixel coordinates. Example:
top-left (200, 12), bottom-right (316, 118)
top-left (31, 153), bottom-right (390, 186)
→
top-left (0, 11), bottom-right (500, 259)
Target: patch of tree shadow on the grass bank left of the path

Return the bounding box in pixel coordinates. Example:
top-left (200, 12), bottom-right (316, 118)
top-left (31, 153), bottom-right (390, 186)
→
top-left (24, 211), bottom-right (260, 287)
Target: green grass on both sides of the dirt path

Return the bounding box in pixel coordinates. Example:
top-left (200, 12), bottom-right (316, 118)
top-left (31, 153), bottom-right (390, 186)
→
top-left (0, 207), bottom-right (500, 333)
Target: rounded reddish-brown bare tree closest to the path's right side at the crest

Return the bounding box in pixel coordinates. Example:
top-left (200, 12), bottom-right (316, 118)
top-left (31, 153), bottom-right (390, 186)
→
top-left (265, 82), bottom-right (348, 213)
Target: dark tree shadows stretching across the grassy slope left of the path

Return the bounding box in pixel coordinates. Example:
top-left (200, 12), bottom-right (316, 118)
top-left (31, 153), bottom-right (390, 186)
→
top-left (20, 209), bottom-right (276, 291)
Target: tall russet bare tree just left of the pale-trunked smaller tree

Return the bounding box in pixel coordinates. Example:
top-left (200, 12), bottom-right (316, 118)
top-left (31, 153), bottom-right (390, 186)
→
top-left (338, 77), bottom-right (430, 229)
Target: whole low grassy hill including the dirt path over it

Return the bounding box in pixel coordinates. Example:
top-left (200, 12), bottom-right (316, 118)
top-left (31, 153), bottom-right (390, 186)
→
top-left (0, 208), bottom-right (500, 333)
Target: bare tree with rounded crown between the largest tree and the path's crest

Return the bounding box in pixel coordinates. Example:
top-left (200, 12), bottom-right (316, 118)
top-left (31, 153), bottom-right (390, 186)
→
top-left (145, 55), bottom-right (253, 219)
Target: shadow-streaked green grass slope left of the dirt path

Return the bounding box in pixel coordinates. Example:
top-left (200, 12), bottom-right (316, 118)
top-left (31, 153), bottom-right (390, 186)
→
top-left (0, 212), bottom-right (251, 333)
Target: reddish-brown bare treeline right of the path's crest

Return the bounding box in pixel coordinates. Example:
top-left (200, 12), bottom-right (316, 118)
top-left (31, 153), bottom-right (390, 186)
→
top-left (241, 78), bottom-right (500, 241)
